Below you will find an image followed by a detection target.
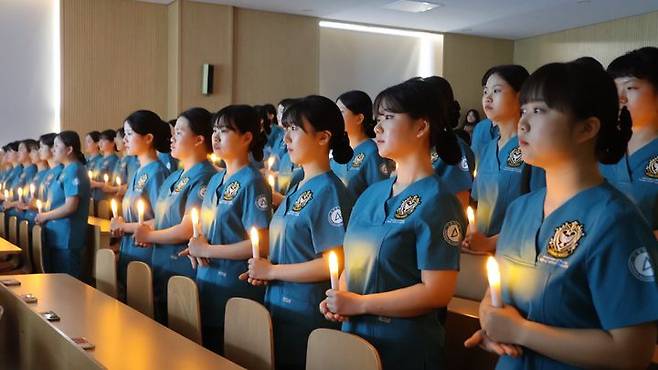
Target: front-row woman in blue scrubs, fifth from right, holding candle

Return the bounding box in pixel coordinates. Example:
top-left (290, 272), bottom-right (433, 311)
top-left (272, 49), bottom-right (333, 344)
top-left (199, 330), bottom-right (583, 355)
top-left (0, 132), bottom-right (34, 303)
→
top-left (133, 108), bottom-right (216, 323)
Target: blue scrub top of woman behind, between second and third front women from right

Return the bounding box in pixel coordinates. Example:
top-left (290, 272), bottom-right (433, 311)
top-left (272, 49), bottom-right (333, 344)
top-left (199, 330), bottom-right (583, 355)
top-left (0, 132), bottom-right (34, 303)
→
top-left (330, 139), bottom-right (395, 199)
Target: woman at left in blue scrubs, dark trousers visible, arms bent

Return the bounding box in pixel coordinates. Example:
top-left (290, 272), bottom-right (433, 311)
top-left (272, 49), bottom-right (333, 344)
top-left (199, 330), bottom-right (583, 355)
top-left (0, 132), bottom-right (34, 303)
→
top-left (35, 131), bottom-right (91, 279)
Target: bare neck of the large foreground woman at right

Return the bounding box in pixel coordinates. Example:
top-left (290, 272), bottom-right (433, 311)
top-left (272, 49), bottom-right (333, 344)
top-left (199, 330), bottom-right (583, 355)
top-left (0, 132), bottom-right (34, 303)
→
top-left (544, 154), bottom-right (603, 216)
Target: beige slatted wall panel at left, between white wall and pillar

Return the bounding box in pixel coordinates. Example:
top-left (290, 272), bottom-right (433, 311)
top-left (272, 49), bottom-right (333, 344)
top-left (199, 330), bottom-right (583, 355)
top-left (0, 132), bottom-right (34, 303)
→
top-left (61, 0), bottom-right (167, 134)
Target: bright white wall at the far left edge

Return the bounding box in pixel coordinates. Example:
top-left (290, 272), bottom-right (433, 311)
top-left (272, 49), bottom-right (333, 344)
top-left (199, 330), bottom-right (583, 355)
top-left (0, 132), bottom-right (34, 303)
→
top-left (0, 0), bottom-right (59, 145)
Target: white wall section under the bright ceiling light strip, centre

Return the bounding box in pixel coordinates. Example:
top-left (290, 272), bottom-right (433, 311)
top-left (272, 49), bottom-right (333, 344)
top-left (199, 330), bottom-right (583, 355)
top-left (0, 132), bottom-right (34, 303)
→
top-left (319, 27), bottom-right (443, 100)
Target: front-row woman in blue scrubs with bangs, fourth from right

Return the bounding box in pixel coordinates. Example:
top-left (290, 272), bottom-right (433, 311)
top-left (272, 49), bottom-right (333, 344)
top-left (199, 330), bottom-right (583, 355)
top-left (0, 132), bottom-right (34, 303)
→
top-left (180, 105), bottom-right (272, 353)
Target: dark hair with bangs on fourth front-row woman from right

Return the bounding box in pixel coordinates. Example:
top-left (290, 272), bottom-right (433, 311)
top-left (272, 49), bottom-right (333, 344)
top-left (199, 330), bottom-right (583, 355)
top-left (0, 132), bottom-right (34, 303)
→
top-left (213, 105), bottom-right (267, 162)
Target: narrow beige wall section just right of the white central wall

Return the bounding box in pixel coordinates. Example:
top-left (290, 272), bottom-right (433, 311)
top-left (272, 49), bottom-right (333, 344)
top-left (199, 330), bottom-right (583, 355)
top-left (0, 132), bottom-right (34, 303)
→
top-left (443, 33), bottom-right (514, 118)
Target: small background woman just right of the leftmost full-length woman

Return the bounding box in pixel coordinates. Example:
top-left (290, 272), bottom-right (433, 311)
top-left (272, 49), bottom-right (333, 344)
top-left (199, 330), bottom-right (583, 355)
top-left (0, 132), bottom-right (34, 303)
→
top-left (91, 130), bottom-right (119, 202)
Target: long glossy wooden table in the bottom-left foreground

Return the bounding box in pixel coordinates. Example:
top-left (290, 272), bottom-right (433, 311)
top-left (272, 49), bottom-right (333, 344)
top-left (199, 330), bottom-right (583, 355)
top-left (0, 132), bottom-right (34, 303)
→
top-left (0, 274), bottom-right (241, 370)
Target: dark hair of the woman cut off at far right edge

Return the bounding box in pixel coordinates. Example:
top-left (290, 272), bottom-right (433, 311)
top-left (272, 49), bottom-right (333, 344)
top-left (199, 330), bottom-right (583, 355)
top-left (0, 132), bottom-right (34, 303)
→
top-left (608, 46), bottom-right (658, 92)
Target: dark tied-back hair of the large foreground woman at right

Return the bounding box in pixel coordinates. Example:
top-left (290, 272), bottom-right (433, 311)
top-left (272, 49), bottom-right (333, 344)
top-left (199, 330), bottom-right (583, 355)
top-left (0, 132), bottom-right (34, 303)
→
top-left (520, 62), bottom-right (632, 164)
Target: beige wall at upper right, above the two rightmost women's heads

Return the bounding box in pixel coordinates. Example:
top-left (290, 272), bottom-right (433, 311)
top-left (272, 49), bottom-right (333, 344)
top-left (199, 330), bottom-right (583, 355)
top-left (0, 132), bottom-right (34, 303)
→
top-left (514, 12), bottom-right (658, 73)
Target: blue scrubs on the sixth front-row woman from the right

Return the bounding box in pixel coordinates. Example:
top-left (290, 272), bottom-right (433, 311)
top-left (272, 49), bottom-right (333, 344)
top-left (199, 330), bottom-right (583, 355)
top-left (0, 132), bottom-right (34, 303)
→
top-left (118, 160), bottom-right (169, 283)
